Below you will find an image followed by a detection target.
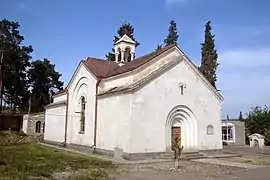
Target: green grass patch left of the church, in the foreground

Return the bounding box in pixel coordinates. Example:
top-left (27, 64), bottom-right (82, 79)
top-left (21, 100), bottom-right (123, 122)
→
top-left (0, 131), bottom-right (114, 180)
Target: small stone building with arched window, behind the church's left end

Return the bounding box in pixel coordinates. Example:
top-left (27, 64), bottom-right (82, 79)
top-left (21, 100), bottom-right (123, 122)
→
top-left (22, 112), bottom-right (45, 136)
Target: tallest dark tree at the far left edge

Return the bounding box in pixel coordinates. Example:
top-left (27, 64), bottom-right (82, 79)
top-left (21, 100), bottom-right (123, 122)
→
top-left (0, 19), bottom-right (33, 111)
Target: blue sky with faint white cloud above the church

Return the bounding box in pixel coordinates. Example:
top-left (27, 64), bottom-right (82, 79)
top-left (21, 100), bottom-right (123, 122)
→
top-left (0, 0), bottom-right (270, 118)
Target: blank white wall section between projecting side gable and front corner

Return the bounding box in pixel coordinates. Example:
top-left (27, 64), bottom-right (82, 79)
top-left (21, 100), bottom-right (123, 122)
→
top-left (97, 94), bottom-right (131, 152)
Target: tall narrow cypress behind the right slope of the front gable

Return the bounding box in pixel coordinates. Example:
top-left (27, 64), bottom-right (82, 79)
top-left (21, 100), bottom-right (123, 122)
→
top-left (199, 21), bottom-right (219, 88)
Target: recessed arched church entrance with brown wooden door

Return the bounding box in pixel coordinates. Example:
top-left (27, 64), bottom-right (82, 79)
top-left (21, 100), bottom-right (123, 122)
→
top-left (165, 105), bottom-right (198, 152)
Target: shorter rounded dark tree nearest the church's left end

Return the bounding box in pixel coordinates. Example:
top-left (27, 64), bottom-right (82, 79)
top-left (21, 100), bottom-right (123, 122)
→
top-left (28, 59), bottom-right (63, 112)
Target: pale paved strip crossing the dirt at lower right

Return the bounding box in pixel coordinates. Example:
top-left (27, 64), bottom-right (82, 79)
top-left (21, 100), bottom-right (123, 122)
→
top-left (193, 159), bottom-right (265, 169)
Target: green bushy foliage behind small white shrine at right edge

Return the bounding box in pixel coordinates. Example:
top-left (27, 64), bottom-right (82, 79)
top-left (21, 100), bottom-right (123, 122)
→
top-left (246, 106), bottom-right (270, 145)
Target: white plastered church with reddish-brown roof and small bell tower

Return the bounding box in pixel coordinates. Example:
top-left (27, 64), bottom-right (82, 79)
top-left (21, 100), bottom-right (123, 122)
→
top-left (44, 35), bottom-right (223, 159)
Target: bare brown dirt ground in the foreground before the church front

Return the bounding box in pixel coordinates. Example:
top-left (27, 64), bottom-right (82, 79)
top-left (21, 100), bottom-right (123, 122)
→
top-left (110, 159), bottom-right (270, 180)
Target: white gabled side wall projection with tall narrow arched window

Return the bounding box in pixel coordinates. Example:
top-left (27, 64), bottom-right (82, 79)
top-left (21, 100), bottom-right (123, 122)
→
top-left (67, 64), bottom-right (97, 146)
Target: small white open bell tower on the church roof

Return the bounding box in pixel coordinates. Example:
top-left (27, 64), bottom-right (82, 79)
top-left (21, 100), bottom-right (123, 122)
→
top-left (114, 34), bottom-right (136, 64)
